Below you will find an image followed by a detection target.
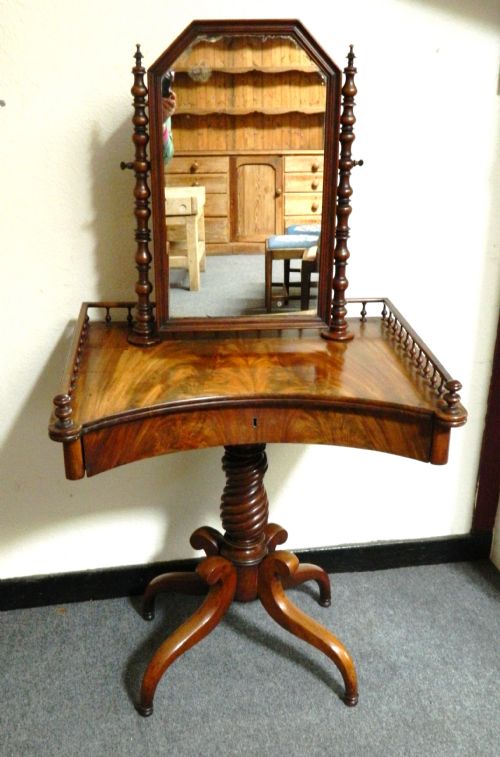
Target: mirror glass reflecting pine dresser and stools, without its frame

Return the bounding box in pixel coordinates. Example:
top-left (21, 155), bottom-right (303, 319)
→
top-left (164, 35), bottom-right (326, 318)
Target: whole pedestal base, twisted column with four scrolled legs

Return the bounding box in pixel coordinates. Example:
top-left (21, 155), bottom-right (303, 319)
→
top-left (137, 444), bottom-right (358, 716)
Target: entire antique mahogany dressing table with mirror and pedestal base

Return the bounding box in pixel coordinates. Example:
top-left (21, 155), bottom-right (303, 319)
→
top-left (49, 20), bottom-right (466, 716)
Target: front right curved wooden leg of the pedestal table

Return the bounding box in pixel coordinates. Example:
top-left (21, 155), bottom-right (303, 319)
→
top-left (258, 552), bottom-right (358, 707)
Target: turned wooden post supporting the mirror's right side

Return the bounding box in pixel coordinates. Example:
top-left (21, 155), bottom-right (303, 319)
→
top-left (322, 45), bottom-right (363, 342)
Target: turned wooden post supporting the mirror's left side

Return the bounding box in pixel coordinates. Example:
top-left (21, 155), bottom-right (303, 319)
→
top-left (120, 45), bottom-right (158, 347)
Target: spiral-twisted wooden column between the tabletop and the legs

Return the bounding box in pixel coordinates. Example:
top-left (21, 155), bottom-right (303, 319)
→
top-left (220, 444), bottom-right (269, 600)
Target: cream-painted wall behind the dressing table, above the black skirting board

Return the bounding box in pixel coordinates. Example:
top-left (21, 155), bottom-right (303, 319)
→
top-left (0, 0), bottom-right (499, 578)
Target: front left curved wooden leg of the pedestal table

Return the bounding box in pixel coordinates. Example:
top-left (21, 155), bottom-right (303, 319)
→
top-left (137, 557), bottom-right (236, 717)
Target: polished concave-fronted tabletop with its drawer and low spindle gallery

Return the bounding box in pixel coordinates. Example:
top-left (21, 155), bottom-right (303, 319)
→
top-left (50, 306), bottom-right (466, 478)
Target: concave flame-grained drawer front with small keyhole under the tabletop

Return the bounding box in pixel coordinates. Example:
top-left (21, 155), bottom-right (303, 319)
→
top-left (82, 407), bottom-right (433, 476)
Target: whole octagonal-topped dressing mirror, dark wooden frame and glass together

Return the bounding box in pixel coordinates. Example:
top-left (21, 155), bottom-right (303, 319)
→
top-left (147, 19), bottom-right (342, 332)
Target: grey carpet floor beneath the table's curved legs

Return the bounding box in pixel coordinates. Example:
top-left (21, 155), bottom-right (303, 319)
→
top-left (0, 563), bottom-right (500, 757)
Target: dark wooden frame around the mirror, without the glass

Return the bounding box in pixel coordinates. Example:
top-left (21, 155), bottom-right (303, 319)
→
top-left (147, 19), bottom-right (342, 335)
